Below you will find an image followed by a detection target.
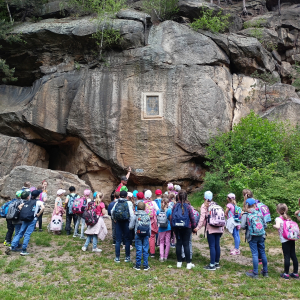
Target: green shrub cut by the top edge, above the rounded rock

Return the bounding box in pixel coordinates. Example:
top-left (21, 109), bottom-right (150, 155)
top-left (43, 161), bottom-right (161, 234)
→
top-left (143, 0), bottom-right (179, 21)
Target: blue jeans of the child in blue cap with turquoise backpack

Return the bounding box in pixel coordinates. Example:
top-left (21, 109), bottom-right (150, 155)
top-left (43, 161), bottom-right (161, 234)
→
top-left (249, 235), bottom-right (268, 274)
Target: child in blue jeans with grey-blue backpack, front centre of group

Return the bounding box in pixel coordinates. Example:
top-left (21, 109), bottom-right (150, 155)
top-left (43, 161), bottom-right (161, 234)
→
top-left (130, 202), bottom-right (151, 271)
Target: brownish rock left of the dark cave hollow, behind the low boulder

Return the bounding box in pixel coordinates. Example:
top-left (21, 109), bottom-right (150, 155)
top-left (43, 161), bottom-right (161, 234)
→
top-left (0, 134), bottom-right (49, 178)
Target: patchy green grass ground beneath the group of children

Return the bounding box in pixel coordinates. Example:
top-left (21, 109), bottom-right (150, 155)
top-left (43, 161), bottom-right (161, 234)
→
top-left (0, 206), bottom-right (300, 300)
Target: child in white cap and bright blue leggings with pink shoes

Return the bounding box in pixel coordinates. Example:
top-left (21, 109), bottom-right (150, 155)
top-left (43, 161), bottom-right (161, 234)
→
top-left (225, 193), bottom-right (241, 255)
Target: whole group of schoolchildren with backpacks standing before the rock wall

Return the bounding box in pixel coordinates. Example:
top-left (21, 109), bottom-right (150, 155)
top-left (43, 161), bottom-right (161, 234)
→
top-left (0, 176), bottom-right (300, 279)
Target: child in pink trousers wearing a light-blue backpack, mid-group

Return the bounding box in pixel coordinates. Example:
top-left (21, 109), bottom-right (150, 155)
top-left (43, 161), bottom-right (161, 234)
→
top-left (157, 199), bottom-right (172, 262)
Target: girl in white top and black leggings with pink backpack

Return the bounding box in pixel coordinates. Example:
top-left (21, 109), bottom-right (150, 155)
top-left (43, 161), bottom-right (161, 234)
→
top-left (273, 203), bottom-right (299, 279)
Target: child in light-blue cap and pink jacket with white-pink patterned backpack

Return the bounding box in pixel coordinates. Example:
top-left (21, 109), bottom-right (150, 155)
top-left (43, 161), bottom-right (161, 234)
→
top-left (195, 191), bottom-right (225, 271)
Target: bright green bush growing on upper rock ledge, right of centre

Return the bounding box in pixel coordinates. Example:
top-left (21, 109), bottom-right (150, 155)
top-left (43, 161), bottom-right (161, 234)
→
top-left (191, 9), bottom-right (230, 33)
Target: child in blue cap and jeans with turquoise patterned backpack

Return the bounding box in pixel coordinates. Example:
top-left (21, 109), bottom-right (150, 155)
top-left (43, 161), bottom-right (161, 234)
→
top-left (241, 198), bottom-right (268, 278)
